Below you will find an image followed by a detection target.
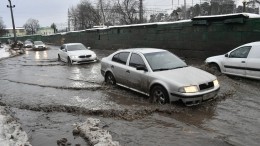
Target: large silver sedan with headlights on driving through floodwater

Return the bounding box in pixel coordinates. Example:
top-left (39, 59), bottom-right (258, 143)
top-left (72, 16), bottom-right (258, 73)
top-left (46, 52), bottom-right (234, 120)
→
top-left (101, 48), bottom-right (220, 106)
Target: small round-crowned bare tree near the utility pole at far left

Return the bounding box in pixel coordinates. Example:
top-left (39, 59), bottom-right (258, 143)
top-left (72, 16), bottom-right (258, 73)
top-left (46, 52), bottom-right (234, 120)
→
top-left (23, 18), bottom-right (40, 34)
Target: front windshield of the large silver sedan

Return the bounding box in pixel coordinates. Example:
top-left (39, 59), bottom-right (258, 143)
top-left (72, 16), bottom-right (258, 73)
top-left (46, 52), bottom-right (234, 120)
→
top-left (144, 51), bottom-right (187, 71)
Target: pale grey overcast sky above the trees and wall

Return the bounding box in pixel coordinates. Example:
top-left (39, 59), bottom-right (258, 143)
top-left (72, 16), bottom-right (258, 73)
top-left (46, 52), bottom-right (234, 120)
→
top-left (0, 0), bottom-right (242, 27)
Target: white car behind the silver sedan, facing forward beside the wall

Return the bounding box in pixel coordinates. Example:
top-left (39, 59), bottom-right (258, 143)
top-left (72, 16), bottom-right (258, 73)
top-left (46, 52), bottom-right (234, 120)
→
top-left (58, 43), bottom-right (97, 65)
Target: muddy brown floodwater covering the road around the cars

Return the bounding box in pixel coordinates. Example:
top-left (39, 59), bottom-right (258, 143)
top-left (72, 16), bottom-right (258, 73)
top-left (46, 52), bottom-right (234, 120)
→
top-left (0, 46), bottom-right (260, 146)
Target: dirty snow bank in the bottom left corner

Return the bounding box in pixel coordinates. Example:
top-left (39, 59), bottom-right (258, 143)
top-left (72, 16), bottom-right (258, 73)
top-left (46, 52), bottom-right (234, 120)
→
top-left (0, 106), bottom-right (31, 146)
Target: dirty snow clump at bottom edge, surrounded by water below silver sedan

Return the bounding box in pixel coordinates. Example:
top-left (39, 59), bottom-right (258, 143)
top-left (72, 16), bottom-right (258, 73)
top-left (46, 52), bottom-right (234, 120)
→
top-left (75, 118), bottom-right (120, 146)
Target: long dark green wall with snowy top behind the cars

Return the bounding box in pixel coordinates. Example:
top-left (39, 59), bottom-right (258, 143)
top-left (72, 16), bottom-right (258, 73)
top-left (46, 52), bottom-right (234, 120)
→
top-left (2, 14), bottom-right (260, 59)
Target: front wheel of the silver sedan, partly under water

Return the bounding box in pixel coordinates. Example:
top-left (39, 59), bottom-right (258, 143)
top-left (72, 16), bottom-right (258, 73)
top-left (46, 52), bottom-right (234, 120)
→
top-left (150, 85), bottom-right (169, 105)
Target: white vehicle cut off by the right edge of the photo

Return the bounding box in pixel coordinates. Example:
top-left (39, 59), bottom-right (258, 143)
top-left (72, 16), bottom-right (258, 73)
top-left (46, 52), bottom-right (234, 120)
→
top-left (205, 42), bottom-right (260, 79)
